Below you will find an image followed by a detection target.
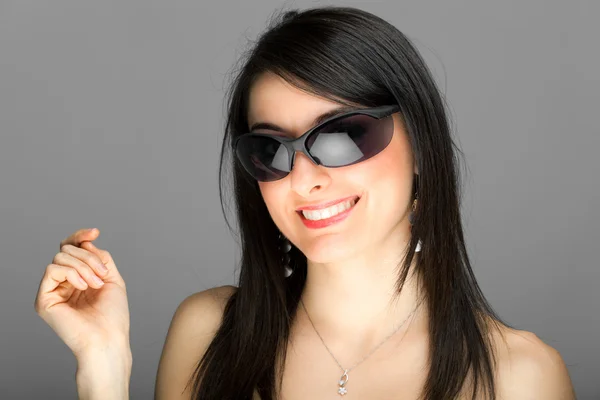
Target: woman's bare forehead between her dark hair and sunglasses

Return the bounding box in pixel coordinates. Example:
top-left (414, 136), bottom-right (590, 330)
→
top-left (248, 72), bottom-right (350, 132)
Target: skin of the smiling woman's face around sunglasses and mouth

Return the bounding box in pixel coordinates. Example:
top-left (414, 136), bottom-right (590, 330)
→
top-left (248, 73), bottom-right (418, 263)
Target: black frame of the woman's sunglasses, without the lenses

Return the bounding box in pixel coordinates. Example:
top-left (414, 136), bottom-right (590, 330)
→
top-left (233, 104), bottom-right (400, 182)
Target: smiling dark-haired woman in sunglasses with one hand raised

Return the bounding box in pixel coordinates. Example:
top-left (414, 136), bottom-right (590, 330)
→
top-left (36, 7), bottom-right (574, 400)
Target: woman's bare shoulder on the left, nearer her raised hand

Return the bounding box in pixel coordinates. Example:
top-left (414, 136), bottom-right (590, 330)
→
top-left (155, 285), bottom-right (237, 400)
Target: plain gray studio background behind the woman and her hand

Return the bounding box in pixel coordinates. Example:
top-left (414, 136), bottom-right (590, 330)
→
top-left (0, 0), bottom-right (600, 399)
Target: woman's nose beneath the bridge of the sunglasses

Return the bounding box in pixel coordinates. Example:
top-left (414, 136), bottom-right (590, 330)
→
top-left (290, 151), bottom-right (331, 197)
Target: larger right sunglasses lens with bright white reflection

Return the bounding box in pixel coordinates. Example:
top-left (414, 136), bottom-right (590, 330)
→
top-left (306, 114), bottom-right (394, 167)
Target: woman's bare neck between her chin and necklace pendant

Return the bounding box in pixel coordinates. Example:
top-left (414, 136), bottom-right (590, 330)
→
top-left (299, 231), bottom-right (427, 347)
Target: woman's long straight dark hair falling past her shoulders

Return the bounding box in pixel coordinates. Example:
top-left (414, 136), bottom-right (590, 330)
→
top-left (188, 6), bottom-right (506, 400)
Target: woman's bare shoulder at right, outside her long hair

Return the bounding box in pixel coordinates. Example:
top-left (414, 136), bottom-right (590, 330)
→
top-left (493, 326), bottom-right (575, 400)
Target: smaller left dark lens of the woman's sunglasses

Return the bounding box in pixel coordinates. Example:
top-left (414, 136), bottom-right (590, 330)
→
top-left (236, 135), bottom-right (289, 182)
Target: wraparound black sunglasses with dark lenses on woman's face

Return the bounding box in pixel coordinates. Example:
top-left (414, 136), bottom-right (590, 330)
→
top-left (233, 105), bottom-right (400, 182)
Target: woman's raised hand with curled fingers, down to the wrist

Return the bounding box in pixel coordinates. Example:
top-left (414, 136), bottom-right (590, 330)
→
top-left (35, 229), bottom-right (130, 360)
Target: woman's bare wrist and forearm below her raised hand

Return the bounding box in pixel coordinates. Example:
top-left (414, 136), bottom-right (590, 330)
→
top-left (75, 349), bottom-right (133, 400)
